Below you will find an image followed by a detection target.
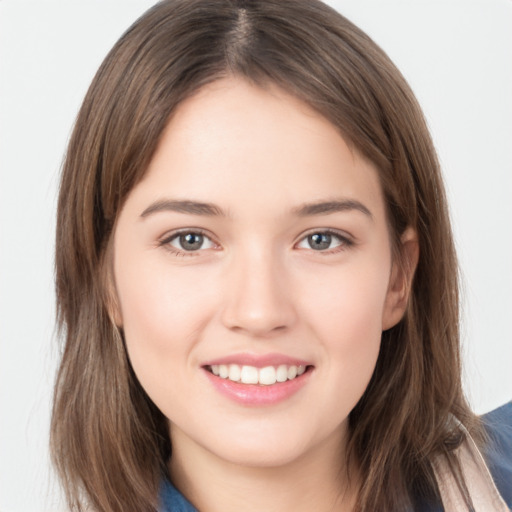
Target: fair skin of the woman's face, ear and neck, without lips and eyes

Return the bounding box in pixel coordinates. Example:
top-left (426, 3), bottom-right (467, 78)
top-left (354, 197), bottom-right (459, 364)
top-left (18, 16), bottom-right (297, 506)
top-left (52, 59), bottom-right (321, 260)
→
top-left (113, 78), bottom-right (417, 512)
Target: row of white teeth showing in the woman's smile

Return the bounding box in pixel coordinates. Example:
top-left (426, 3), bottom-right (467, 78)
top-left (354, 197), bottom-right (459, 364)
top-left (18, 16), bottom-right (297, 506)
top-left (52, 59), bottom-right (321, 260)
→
top-left (205, 364), bottom-right (313, 386)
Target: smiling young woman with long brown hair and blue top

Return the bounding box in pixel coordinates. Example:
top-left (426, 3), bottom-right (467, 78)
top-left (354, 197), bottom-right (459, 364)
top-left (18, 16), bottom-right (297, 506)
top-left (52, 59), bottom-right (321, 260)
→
top-left (52, 0), bottom-right (512, 512)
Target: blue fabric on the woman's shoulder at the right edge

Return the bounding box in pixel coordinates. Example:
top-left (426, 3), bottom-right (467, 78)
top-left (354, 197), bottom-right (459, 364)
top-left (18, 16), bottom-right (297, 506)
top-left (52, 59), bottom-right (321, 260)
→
top-left (481, 402), bottom-right (512, 507)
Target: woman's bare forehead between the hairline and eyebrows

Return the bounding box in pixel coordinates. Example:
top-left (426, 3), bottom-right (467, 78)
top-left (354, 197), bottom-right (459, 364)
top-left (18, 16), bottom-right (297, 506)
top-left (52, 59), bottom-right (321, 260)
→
top-left (126, 78), bottom-right (384, 222)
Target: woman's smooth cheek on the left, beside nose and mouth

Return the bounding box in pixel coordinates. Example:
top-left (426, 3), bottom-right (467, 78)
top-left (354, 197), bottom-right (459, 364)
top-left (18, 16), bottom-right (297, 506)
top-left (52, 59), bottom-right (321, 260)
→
top-left (116, 255), bottom-right (214, 374)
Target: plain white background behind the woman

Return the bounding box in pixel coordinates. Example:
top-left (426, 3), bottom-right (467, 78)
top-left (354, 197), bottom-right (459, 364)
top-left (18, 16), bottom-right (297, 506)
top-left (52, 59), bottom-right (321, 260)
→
top-left (0, 0), bottom-right (512, 512)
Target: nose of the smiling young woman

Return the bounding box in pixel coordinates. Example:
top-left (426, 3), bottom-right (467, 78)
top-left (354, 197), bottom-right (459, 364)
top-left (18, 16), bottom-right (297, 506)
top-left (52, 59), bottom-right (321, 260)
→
top-left (222, 247), bottom-right (297, 337)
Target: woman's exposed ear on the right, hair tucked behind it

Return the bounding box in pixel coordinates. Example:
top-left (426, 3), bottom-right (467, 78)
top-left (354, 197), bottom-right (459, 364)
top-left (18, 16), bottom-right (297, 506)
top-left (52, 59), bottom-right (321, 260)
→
top-left (382, 227), bottom-right (419, 331)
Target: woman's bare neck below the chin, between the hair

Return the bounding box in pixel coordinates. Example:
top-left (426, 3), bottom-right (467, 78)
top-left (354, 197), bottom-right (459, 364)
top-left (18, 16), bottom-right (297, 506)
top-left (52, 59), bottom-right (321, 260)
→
top-left (170, 429), bottom-right (359, 512)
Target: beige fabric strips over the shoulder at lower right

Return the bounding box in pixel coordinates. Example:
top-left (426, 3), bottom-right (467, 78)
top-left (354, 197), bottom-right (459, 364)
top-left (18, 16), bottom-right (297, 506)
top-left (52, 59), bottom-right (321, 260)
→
top-left (433, 434), bottom-right (510, 512)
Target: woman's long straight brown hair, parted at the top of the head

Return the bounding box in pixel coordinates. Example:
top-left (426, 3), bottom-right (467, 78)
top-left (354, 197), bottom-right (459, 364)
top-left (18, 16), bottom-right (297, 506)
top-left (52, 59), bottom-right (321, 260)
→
top-left (51, 0), bottom-right (478, 512)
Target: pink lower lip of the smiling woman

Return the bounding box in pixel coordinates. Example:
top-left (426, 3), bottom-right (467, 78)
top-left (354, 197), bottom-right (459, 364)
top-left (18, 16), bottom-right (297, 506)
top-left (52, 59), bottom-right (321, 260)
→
top-left (204, 368), bottom-right (312, 406)
